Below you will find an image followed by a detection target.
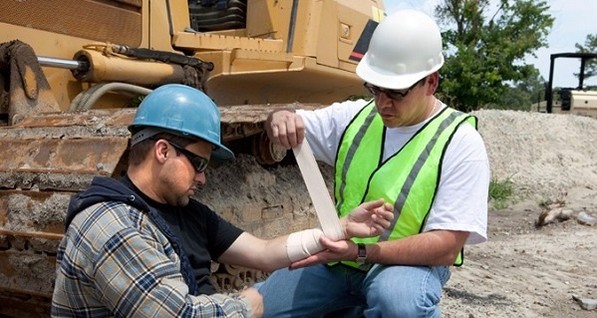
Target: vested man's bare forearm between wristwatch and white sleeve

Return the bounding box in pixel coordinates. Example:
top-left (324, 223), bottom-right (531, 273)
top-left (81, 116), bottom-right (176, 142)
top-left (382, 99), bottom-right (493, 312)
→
top-left (367, 230), bottom-right (469, 266)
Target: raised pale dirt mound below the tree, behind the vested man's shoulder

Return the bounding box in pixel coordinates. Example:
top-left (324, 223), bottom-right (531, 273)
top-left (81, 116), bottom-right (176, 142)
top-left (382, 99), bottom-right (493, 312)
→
top-left (473, 110), bottom-right (597, 200)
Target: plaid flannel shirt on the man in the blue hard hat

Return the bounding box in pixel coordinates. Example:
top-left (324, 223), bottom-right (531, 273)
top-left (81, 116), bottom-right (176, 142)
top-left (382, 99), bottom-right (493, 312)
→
top-left (52, 201), bottom-right (251, 317)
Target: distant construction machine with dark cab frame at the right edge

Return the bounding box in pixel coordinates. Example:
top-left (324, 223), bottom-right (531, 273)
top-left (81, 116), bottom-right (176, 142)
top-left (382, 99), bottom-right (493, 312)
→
top-left (539, 52), bottom-right (597, 118)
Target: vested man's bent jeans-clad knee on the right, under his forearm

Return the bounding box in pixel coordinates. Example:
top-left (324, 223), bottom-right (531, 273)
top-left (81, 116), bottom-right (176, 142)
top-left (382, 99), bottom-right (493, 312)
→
top-left (364, 265), bottom-right (450, 318)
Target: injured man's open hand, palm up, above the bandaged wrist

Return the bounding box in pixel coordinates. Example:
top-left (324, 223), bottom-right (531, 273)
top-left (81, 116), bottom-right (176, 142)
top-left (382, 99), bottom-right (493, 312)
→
top-left (340, 199), bottom-right (394, 239)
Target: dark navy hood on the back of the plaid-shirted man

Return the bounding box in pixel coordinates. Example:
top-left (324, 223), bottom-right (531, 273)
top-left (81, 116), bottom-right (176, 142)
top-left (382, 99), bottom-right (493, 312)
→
top-left (65, 177), bottom-right (150, 230)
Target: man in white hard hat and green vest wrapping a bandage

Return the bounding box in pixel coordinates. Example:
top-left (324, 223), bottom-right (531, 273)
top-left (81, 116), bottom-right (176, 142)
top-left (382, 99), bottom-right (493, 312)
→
top-left (257, 10), bottom-right (490, 317)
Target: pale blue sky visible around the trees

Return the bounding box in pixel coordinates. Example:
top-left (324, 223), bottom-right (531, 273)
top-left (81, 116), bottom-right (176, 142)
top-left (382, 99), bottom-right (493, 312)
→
top-left (384, 0), bottom-right (597, 87)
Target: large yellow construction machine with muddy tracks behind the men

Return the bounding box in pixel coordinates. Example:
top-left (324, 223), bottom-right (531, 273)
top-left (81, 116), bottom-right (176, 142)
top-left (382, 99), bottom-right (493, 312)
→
top-left (0, 0), bottom-right (384, 317)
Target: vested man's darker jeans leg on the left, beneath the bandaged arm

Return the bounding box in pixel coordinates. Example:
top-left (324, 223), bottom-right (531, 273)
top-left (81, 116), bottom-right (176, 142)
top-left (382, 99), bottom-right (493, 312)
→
top-left (254, 265), bottom-right (365, 318)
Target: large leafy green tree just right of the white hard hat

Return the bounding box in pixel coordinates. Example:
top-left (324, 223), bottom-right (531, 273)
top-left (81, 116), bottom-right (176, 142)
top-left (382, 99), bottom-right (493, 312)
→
top-left (436, 0), bottom-right (554, 111)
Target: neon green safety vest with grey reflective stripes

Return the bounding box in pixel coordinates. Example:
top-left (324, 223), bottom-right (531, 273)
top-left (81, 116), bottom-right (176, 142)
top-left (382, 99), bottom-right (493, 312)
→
top-left (334, 102), bottom-right (477, 269)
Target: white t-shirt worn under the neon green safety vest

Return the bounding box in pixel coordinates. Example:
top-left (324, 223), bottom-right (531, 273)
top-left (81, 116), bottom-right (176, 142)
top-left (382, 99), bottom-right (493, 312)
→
top-left (297, 100), bottom-right (490, 244)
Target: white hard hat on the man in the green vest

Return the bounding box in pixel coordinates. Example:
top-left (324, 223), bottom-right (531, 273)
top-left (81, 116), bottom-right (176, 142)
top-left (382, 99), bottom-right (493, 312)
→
top-left (357, 9), bottom-right (444, 89)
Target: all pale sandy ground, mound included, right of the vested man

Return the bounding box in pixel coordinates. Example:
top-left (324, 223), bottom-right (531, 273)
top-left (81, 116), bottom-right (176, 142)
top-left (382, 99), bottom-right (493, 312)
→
top-left (442, 111), bottom-right (597, 318)
